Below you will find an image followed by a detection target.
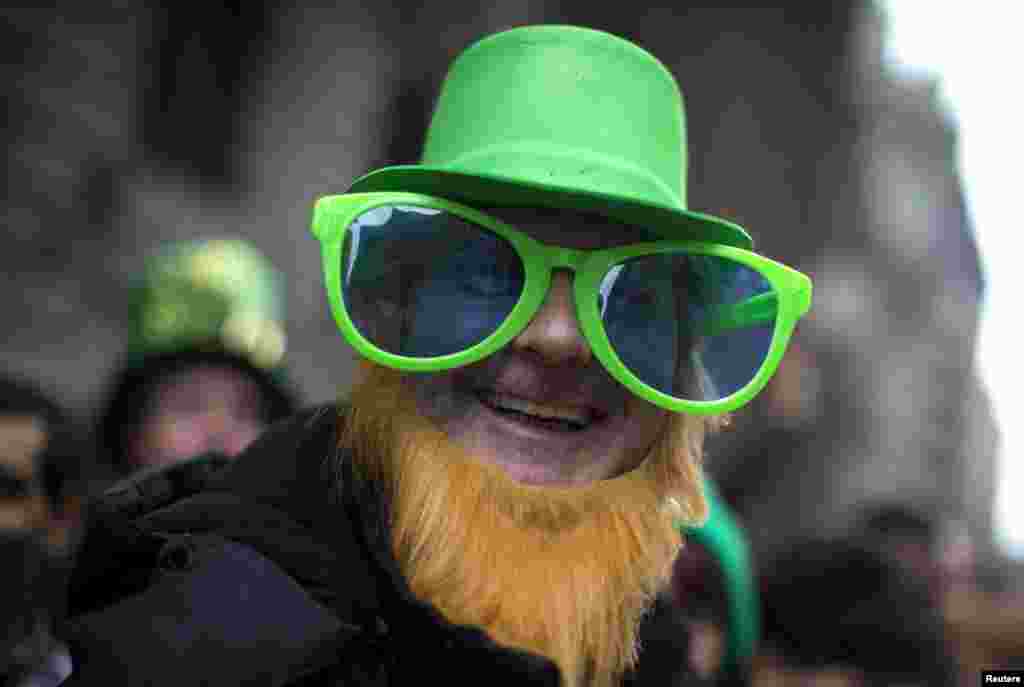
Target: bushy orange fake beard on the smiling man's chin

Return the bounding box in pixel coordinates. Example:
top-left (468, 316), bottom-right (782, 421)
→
top-left (340, 363), bottom-right (707, 687)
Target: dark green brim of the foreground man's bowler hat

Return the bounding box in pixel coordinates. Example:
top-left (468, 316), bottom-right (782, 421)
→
top-left (348, 165), bottom-right (754, 250)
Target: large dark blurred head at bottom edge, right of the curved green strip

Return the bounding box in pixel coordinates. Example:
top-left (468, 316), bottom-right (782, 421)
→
top-left (754, 539), bottom-right (958, 687)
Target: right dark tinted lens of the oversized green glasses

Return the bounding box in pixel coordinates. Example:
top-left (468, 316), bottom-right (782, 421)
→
top-left (598, 253), bottom-right (776, 401)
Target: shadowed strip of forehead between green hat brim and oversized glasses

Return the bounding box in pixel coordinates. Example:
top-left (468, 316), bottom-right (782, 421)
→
top-left (483, 208), bottom-right (657, 250)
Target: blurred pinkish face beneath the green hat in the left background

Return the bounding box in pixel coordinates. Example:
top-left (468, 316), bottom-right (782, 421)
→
top-left (130, 366), bottom-right (265, 467)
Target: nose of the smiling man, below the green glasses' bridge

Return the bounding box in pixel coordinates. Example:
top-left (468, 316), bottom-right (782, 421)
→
top-left (512, 270), bottom-right (592, 367)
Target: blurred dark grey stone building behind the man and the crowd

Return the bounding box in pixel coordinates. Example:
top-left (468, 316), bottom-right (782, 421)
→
top-left (0, 0), bottom-right (997, 565)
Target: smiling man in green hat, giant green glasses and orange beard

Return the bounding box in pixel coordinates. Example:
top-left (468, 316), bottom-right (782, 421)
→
top-left (59, 27), bottom-right (810, 686)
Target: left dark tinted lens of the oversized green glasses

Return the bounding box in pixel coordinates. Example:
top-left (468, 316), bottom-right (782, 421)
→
top-left (341, 205), bottom-right (525, 357)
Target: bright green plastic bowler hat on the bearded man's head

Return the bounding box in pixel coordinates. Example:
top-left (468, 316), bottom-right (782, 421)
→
top-left (349, 26), bottom-right (753, 249)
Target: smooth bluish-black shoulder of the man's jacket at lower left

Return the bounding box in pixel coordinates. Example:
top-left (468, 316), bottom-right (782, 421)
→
top-left (61, 534), bottom-right (358, 687)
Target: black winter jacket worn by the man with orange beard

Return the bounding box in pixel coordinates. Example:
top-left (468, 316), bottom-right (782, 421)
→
top-left (60, 405), bottom-right (704, 687)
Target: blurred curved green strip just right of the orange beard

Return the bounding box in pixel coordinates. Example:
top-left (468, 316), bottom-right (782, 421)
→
top-left (680, 477), bottom-right (761, 671)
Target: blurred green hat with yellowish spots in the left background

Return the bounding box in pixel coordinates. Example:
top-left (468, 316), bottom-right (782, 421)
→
top-left (127, 239), bottom-right (286, 370)
